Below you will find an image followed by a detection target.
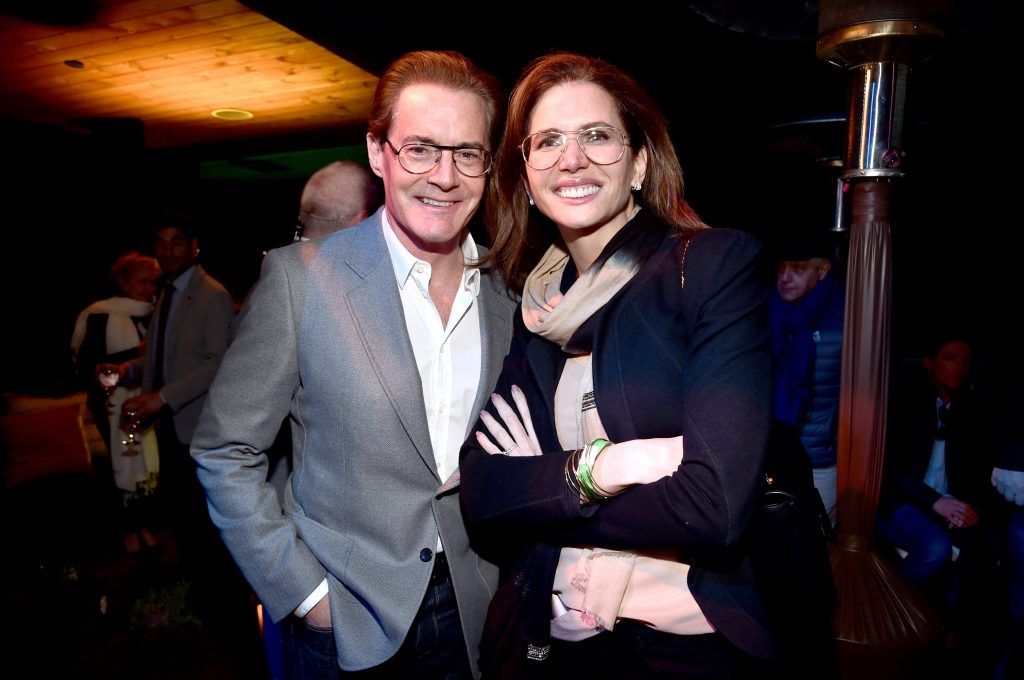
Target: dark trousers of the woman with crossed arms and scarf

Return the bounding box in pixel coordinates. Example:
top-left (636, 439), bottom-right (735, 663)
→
top-left (549, 620), bottom-right (761, 680)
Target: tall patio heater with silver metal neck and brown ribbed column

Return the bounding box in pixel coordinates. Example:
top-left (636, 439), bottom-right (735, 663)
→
top-left (817, 0), bottom-right (952, 680)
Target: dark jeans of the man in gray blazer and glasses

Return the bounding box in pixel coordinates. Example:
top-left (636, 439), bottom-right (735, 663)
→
top-left (284, 553), bottom-right (471, 680)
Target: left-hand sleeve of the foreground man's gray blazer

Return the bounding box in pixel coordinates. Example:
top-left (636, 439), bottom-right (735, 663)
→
top-left (191, 251), bottom-right (327, 621)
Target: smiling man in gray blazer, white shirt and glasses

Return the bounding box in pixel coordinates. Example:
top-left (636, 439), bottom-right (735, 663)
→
top-left (193, 52), bottom-right (515, 678)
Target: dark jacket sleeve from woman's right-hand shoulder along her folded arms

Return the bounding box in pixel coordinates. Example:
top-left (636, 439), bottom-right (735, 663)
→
top-left (462, 230), bottom-right (771, 549)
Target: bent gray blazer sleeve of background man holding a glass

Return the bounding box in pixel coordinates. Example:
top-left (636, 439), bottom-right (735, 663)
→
top-left (160, 272), bottom-right (234, 413)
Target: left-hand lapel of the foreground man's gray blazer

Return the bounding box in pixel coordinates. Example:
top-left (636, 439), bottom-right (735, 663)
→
top-left (345, 212), bottom-right (440, 482)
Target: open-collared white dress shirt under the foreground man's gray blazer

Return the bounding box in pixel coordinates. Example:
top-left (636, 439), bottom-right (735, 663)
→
top-left (295, 209), bottom-right (481, 618)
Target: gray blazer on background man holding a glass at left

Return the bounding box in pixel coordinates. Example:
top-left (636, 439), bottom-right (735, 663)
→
top-left (139, 264), bottom-right (234, 444)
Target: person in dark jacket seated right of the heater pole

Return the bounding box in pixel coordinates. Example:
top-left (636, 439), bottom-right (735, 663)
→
top-left (878, 336), bottom-right (1006, 677)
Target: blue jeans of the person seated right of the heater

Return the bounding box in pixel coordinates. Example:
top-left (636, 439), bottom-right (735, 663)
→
top-left (878, 505), bottom-right (953, 586)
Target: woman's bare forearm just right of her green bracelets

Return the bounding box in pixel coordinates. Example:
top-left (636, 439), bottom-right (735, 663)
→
top-left (593, 436), bottom-right (683, 494)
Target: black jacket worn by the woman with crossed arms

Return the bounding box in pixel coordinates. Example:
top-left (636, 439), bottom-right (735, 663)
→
top-left (461, 213), bottom-right (772, 656)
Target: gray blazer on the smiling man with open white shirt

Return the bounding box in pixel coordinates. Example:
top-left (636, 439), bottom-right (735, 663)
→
top-left (193, 212), bottom-right (516, 673)
